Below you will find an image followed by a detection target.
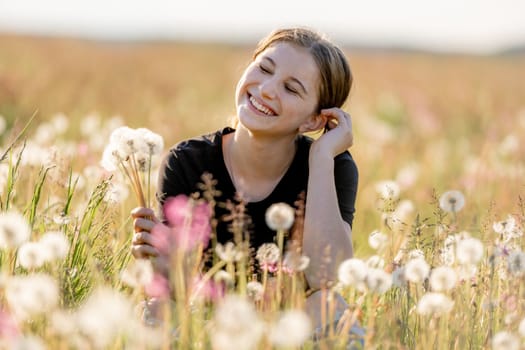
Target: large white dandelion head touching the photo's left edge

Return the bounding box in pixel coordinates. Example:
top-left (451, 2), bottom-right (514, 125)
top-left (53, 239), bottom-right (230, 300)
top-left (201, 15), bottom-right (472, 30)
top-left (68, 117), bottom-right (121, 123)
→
top-left (0, 211), bottom-right (31, 249)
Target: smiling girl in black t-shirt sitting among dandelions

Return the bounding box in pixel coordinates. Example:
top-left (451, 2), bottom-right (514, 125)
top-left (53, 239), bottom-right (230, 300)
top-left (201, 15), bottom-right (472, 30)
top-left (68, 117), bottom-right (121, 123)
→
top-left (132, 28), bottom-right (358, 344)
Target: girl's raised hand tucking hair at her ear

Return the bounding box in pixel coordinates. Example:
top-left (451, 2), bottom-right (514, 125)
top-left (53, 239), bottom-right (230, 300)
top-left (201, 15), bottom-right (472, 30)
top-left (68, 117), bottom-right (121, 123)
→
top-left (312, 107), bottom-right (354, 157)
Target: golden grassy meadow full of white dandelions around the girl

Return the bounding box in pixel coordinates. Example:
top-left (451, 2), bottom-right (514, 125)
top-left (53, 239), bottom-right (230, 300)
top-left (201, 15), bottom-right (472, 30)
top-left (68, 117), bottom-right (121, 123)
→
top-left (0, 35), bottom-right (525, 349)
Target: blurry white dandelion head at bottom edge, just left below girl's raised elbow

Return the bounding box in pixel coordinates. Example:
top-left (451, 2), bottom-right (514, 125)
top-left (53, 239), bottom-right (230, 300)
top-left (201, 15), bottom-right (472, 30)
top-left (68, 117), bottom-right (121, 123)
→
top-left (270, 310), bottom-right (312, 348)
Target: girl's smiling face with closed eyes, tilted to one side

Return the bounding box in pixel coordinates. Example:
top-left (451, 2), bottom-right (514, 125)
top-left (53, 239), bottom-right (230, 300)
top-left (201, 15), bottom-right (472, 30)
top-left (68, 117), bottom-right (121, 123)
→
top-left (236, 42), bottom-right (320, 135)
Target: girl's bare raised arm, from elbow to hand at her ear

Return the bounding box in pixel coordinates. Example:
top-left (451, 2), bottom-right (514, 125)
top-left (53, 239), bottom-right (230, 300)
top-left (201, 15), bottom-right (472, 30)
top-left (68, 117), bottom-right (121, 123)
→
top-left (303, 108), bottom-right (353, 289)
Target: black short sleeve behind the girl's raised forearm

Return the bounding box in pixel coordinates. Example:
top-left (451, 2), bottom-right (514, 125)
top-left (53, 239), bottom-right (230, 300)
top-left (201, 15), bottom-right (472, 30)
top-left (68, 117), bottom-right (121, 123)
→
top-left (334, 151), bottom-right (359, 227)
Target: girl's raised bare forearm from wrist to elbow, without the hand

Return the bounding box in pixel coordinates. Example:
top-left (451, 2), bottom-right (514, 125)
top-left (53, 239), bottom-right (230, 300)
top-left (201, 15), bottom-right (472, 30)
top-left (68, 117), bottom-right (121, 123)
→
top-left (303, 149), bottom-right (353, 288)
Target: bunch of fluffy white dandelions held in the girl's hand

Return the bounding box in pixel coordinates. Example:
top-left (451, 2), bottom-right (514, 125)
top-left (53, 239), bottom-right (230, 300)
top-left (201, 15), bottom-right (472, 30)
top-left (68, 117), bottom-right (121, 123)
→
top-left (101, 126), bottom-right (164, 207)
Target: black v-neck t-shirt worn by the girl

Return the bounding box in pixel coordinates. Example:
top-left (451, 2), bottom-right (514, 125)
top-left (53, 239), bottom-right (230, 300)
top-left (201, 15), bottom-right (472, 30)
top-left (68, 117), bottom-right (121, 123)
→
top-left (157, 127), bottom-right (358, 250)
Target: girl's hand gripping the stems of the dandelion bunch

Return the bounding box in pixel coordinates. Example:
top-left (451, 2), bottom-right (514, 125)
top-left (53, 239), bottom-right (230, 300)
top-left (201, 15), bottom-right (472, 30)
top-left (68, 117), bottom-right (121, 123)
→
top-left (131, 207), bottom-right (160, 259)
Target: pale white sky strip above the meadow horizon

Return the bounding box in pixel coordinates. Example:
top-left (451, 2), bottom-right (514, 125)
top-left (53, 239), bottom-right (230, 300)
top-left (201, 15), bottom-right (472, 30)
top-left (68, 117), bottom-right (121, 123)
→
top-left (0, 0), bottom-right (525, 54)
